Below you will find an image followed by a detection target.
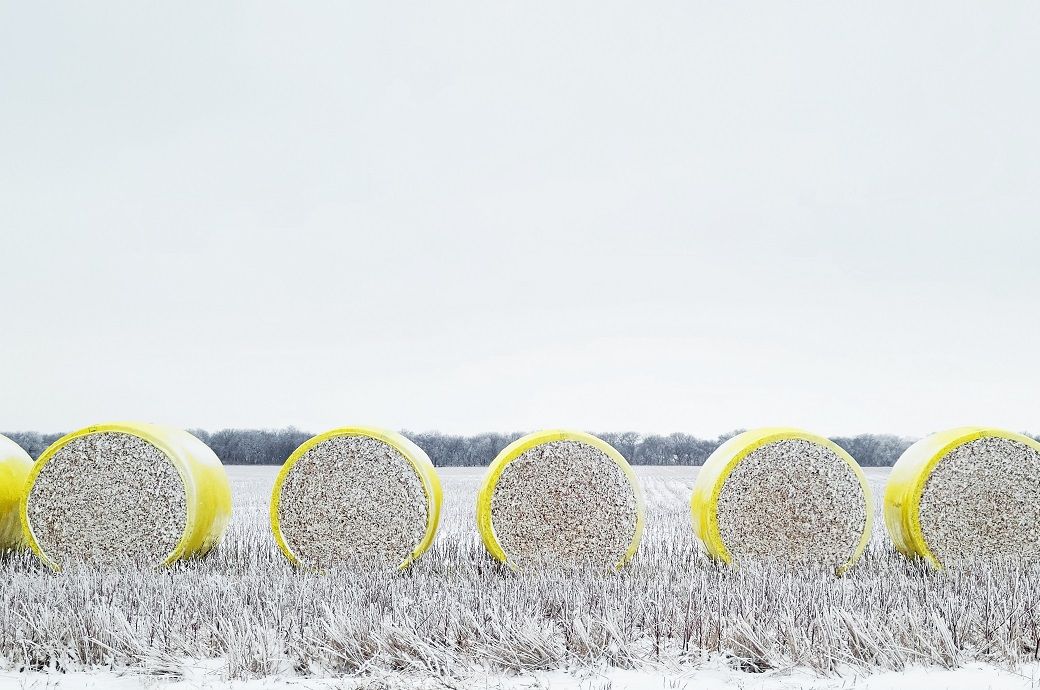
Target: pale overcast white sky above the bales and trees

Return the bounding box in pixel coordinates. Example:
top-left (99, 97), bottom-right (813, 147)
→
top-left (0, 0), bottom-right (1040, 435)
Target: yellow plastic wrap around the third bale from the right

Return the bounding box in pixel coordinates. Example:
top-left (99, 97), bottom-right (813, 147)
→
top-left (476, 429), bottom-right (646, 570)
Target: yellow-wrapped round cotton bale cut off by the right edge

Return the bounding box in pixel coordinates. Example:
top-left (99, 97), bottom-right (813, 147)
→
top-left (885, 427), bottom-right (1040, 568)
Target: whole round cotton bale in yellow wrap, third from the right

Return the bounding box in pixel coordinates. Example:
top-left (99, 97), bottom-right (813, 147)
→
top-left (476, 431), bottom-right (645, 569)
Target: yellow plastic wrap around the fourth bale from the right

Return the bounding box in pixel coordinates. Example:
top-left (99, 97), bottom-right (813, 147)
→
top-left (269, 427), bottom-right (443, 570)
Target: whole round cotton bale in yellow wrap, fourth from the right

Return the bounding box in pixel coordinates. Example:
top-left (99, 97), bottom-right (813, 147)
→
top-left (270, 427), bottom-right (441, 570)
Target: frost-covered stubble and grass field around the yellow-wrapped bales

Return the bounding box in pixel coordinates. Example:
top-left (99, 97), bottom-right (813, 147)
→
top-left (0, 467), bottom-right (1040, 682)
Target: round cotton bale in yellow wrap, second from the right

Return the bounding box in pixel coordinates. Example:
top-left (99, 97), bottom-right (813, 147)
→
top-left (691, 429), bottom-right (874, 572)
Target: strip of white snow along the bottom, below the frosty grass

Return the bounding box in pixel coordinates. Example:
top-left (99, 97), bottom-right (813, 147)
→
top-left (6, 664), bottom-right (1040, 690)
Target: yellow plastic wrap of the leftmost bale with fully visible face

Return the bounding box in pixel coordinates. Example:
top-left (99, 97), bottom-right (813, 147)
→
top-left (21, 421), bottom-right (231, 571)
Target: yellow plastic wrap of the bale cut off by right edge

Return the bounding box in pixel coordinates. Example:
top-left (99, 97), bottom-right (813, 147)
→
top-left (884, 427), bottom-right (1040, 570)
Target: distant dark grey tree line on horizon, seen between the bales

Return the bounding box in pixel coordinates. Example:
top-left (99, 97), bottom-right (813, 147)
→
top-left (4, 427), bottom-right (952, 467)
